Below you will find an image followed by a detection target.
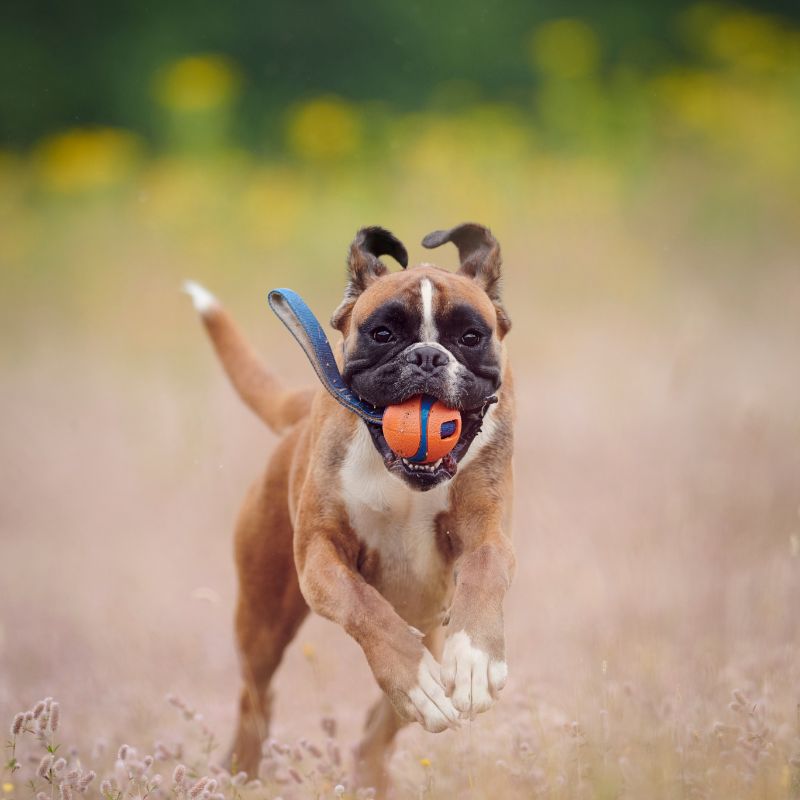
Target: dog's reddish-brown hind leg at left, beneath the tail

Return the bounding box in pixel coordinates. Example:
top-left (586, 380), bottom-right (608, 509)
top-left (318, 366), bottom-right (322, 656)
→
top-left (229, 437), bottom-right (308, 777)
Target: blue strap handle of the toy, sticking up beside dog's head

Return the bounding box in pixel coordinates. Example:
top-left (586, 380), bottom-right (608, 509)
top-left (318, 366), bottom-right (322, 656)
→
top-left (267, 289), bottom-right (383, 425)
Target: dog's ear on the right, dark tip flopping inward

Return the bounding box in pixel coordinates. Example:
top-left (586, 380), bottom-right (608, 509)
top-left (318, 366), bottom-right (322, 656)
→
top-left (422, 222), bottom-right (511, 335)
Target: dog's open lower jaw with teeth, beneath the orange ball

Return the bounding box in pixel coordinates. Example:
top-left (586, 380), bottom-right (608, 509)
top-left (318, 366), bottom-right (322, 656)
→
top-left (364, 396), bottom-right (497, 492)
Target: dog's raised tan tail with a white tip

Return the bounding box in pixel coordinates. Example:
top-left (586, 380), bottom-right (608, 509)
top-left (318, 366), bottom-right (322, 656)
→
top-left (183, 281), bottom-right (314, 433)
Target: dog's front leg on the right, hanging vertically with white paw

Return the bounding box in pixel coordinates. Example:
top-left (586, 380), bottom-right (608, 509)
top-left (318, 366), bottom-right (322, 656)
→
top-left (442, 526), bottom-right (515, 717)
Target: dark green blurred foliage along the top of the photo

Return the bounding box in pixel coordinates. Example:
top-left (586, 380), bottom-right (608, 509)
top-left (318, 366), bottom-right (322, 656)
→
top-left (0, 0), bottom-right (800, 149)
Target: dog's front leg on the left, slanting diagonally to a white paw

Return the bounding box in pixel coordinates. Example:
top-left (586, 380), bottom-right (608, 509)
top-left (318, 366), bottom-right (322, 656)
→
top-left (295, 524), bottom-right (458, 733)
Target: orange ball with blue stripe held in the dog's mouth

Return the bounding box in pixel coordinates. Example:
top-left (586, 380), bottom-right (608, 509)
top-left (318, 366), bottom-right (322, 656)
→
top-left (383, 394), bottom-right (461, 464)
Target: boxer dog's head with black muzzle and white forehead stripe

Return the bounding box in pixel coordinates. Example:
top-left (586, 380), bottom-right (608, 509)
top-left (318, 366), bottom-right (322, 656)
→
top-left (331, 223), bottom-right (511, 491)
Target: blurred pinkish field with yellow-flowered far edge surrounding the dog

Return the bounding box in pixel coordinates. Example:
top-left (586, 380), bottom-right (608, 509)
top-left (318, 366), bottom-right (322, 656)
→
top-left (0, 10), bottom-right (800, 800)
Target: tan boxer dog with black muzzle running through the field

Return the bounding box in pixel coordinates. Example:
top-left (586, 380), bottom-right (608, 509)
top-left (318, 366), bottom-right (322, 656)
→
top-left (186, 223), bottom-right (515, 792)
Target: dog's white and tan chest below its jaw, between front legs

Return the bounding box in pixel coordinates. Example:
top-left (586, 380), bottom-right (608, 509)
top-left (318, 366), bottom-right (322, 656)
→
top-left (341, 425), bottom-right (452, 630)
